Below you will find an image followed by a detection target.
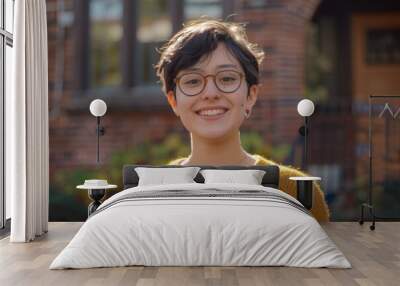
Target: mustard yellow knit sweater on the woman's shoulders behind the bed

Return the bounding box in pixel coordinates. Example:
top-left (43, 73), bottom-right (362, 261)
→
top-left (168, 154), bottom-right (329, 222)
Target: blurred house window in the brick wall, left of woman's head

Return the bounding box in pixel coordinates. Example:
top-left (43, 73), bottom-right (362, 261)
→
top-left (75, 0), bottom-right (231, 96)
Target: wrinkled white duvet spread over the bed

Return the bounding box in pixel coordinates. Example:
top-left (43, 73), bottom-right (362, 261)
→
top-left (50, 183), bottom-right (351, 269)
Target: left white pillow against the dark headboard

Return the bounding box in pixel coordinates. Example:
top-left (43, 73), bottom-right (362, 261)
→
top-left (135, 167), bottom-right (200, 186)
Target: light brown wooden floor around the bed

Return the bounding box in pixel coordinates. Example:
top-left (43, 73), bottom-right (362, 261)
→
top-left (0, 222), bottom-right (400, 286)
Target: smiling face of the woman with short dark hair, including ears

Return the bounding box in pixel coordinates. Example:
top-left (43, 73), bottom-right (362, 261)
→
top-left (167, 44), bottom-right (258, 139)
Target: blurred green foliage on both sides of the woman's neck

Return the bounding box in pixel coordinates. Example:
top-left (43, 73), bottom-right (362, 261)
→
top-left (50, 132), bottom-right (290, 221)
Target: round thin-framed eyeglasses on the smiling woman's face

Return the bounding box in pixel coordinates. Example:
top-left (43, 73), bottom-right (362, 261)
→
top-left (175, 70), bottom-right (244, 96)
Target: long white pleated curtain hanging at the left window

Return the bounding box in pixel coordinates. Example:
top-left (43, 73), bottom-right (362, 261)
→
top-left (6, 0), bottom-right (49, 242)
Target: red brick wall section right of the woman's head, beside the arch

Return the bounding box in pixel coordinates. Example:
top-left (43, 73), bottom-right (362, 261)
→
top-left (238, 0), bottom-right (319, 144)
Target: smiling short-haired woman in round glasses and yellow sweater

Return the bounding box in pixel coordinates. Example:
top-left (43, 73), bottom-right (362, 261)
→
top-left (156, 20), bottom-right (329, 222)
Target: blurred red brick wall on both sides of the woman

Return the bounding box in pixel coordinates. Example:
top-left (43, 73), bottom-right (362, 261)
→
top-left (47, 0), bottom-right (319, 174)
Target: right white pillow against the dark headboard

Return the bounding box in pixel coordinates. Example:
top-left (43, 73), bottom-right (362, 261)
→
top-left (200, 169), bottom-right (266, 185)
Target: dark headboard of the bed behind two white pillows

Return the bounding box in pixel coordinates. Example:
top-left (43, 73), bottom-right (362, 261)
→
top-left (122, 165), bottom-right (279, 190)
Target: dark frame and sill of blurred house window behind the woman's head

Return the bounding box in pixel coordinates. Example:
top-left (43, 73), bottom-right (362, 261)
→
top-left (66, 0), bottom-right (233, 111)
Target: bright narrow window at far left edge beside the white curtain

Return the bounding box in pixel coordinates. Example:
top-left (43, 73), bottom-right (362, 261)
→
top-left (0, 0), bottom-right (14, 228)
